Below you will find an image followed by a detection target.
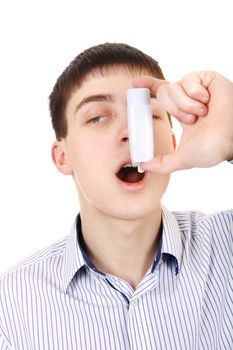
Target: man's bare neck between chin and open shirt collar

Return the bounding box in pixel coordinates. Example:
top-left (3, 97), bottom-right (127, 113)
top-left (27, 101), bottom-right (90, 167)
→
top-left (81, 207), bottom-right (161, 289)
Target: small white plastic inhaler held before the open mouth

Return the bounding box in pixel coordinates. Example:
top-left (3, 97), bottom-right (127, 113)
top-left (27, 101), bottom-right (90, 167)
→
top-left (127, 88), bottom-right (154, 172)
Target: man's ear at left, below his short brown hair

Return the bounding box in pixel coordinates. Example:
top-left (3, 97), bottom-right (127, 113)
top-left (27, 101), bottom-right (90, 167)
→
top-left (51, 141), bottom-right (73, 175)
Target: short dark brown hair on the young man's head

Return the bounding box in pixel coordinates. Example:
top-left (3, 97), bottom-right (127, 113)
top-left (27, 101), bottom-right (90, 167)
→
top-left (49, 43), bottom-right (164, 140)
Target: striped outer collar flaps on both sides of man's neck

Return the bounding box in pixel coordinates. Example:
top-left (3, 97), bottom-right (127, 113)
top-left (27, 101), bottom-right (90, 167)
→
top-left (63, 206), bottom-right (182, 291)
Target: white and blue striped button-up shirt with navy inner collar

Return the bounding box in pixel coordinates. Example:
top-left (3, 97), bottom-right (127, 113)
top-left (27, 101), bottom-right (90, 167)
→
top-left (0, 208), bottom-right (233, 350)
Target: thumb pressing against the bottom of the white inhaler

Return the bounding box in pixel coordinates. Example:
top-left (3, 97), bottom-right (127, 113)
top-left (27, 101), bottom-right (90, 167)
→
top-left (140, 152), bottom-right (192, 174)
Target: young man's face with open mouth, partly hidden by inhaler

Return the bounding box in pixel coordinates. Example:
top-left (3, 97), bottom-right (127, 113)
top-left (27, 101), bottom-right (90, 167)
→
top-left (53, 68), bottom-right (173, 220)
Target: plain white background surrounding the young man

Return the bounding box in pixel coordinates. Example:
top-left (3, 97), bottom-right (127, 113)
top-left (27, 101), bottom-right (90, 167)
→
top-left (0, 0), bottom-right (233, 272)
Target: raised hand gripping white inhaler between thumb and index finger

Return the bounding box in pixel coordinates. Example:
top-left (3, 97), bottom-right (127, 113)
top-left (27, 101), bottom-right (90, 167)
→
top-left (133, 72), bottom-right (233, 173)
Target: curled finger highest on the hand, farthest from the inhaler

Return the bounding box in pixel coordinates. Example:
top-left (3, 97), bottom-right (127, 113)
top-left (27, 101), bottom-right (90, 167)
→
top-left (181, 73), bottom-right (210, 104)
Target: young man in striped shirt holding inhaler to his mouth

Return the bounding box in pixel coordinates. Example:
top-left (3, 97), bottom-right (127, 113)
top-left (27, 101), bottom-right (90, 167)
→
top-left (0, 44), bottom-right (233, 350)
